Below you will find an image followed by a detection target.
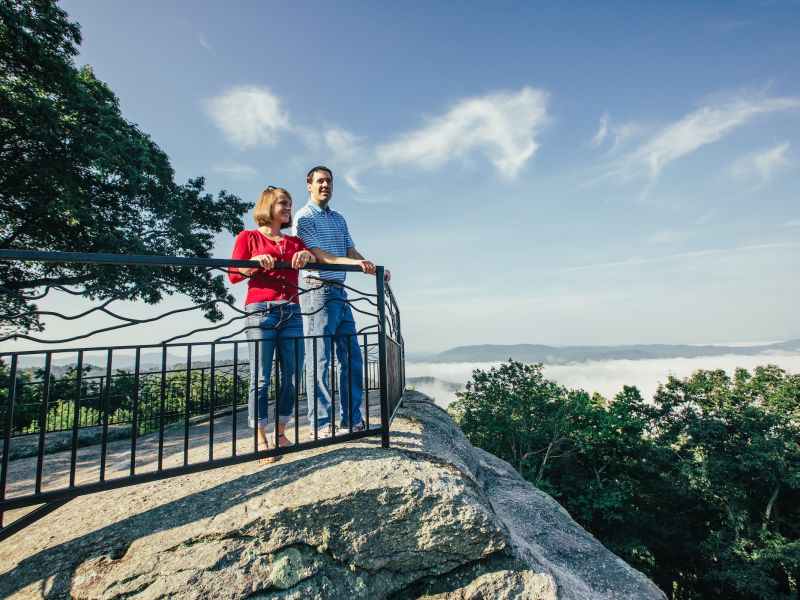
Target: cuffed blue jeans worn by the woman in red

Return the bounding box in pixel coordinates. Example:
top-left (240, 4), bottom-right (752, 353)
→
top-left (245, 302), bottom-right (303, 428)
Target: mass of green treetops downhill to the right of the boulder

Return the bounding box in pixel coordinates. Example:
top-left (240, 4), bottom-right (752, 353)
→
top-left (451, 361), bottom-right (800, 599)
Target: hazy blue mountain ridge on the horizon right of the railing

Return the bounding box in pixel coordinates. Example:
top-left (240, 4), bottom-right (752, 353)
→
top-left (425, 338), bottom-right (800, 365)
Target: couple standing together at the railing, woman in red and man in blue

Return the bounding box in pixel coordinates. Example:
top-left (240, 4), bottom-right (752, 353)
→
top-left (228, 166), bottom-right (390, 462)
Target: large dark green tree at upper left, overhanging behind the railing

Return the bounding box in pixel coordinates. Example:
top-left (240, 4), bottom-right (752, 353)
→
top-left (0, 0), bottom-right (251, 331)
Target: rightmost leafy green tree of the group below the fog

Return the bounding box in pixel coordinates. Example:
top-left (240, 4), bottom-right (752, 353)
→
top-left (654, 366), bottom-right (800, 599)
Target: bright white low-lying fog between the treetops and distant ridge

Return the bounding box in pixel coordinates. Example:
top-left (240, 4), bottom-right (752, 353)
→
top-left (406, 354), bottom-right (800, 406)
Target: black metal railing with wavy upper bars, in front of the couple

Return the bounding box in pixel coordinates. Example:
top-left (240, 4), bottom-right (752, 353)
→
top-left (0, 250), bottom-right (405, 540)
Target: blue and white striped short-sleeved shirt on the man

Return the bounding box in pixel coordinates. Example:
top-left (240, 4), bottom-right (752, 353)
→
top-left (294, 200), bottom-right (355, 282)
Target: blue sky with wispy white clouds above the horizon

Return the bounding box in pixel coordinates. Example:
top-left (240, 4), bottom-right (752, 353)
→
top-left (61, 0), bottom-right (800, 352)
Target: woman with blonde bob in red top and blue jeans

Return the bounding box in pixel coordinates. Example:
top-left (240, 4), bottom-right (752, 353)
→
top-left (228, 186), bottom-right (314, 463)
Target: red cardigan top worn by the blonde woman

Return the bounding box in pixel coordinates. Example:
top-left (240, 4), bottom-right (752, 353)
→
top-left (228, 229), bottom-right (307, 304)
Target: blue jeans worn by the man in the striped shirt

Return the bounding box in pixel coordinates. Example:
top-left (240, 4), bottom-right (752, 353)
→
top-left (300, 285), bottom-right (364, 428)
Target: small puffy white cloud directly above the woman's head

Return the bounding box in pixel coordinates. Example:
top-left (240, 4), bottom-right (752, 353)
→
top-left (206, 86), bottom-right (290, 149)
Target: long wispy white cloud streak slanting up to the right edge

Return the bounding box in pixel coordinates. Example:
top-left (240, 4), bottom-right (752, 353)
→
top-left (598, 95), bottom-right (800, 183)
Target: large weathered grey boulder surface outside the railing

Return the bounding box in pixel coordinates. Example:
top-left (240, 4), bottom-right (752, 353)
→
top-left (0, 393), bottom-right (664, 600)
